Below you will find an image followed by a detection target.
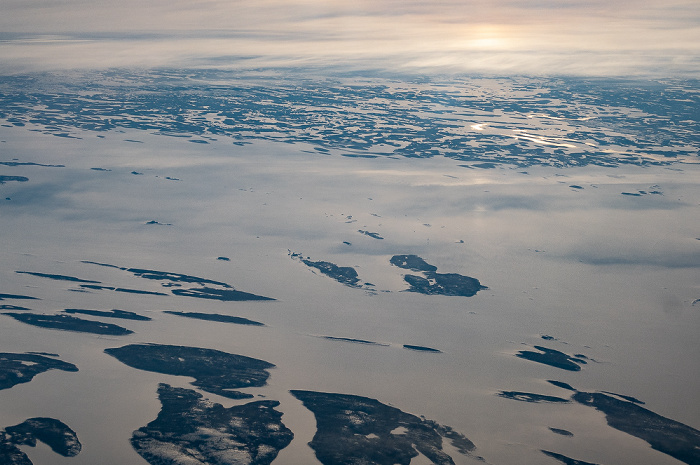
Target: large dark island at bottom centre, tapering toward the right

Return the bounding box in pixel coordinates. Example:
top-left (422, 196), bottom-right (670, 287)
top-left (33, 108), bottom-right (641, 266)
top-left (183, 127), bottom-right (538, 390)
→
top-left (290, 390), bottom-right (476, 465)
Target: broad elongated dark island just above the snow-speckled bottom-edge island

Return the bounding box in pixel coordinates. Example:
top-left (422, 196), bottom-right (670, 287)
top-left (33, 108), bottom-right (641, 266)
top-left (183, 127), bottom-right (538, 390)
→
top-left (105, 344), bottom-right (275, 399)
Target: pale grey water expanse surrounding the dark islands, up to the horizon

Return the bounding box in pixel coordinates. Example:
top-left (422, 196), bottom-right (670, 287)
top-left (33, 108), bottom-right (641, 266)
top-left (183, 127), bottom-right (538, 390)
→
top-left (0, 71), bottom-right (700, 465)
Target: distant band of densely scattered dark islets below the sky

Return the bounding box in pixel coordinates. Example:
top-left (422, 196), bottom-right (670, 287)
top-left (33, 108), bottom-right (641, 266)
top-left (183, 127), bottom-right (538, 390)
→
top-left (0, 69), bottom-right (697, 169)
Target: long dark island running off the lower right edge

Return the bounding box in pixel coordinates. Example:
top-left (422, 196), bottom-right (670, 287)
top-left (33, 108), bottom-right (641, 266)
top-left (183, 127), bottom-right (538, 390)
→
top-left (572, 392), bottom-right (700, 465)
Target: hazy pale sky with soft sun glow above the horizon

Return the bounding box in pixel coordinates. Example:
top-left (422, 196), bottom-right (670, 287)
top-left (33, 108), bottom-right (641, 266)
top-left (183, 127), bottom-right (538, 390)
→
top-left (0, 0), bottom-right (700, 77)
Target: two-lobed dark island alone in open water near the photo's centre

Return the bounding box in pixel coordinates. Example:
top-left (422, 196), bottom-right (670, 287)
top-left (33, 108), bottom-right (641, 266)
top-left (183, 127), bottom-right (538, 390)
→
top-left (390, 255), bottom-right (488, 297)
